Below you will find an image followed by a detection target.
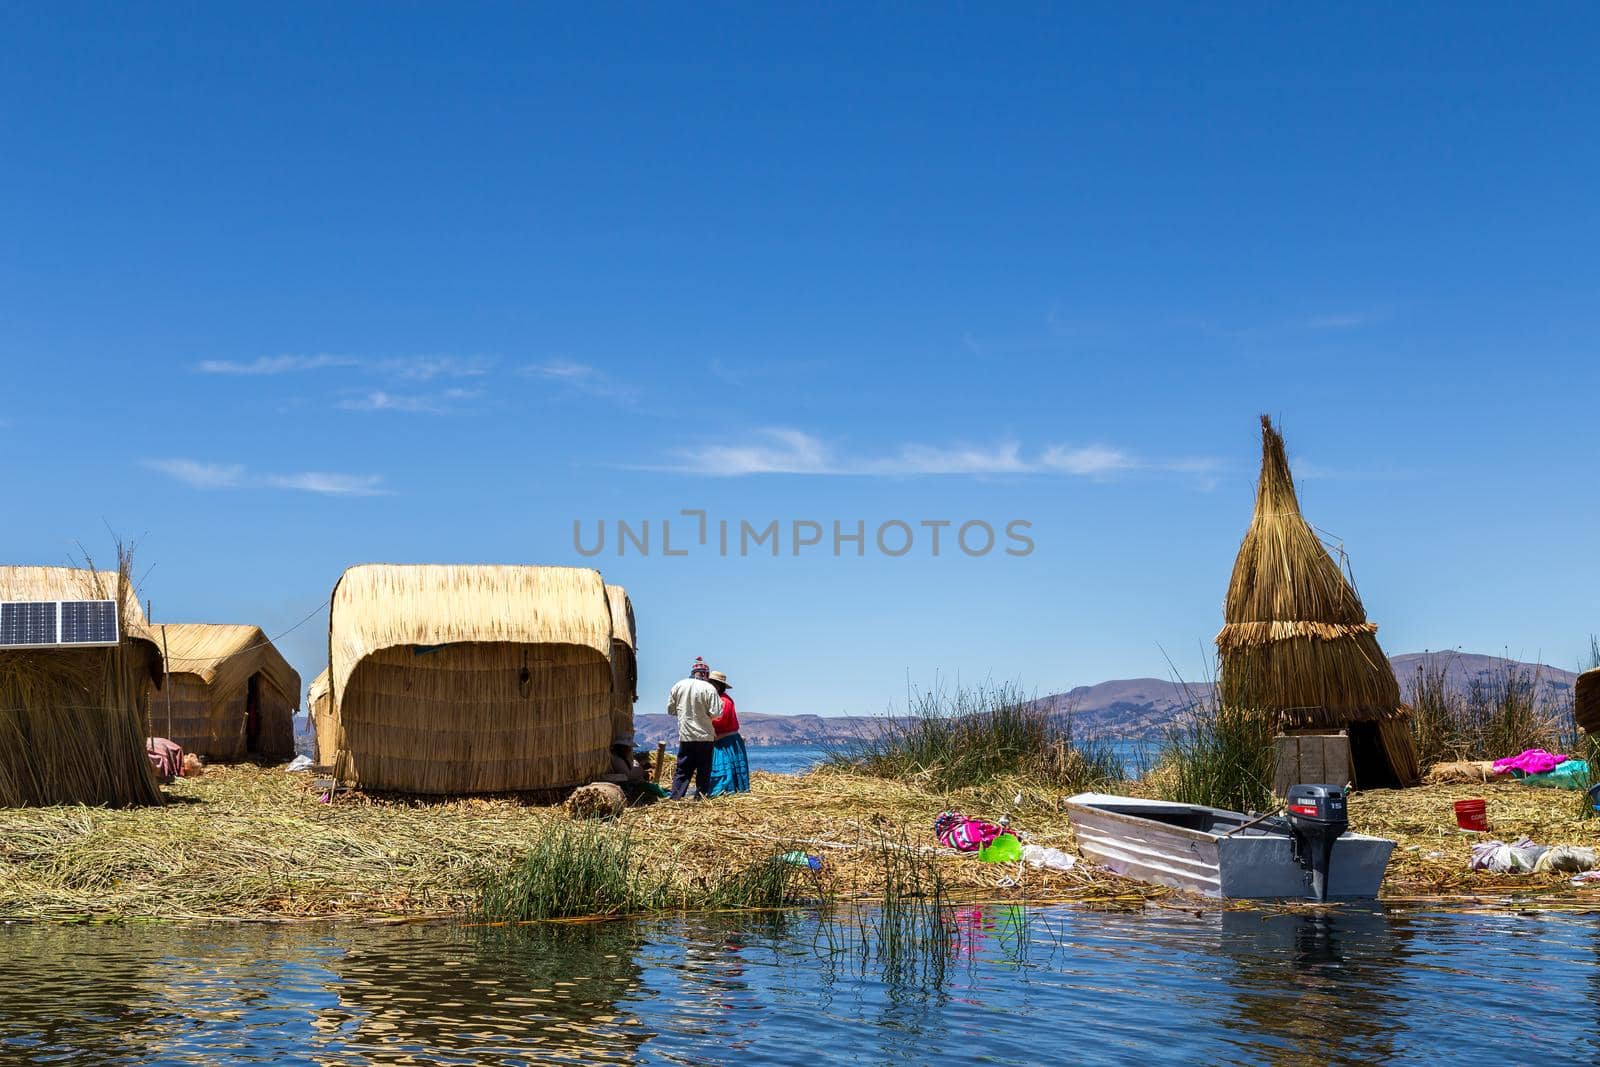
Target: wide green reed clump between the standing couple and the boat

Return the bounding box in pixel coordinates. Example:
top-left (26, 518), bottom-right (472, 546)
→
top-left (827, 681), bottom-right (1123, 792)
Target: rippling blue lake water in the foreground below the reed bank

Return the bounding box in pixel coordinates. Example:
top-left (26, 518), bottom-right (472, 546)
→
top-left (0, 909), bottom-right (1600, 1065)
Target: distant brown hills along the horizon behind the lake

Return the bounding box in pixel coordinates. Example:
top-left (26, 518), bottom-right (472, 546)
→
top-left (634, 653), bottom-right (1578, 745)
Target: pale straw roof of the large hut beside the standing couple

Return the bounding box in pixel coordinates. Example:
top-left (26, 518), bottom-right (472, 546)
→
top-left (328, 563), bottom-right (611, 701)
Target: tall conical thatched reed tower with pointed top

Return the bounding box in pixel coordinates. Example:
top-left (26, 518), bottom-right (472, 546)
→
top-left (1216, 416), bottom-right (1419, 787)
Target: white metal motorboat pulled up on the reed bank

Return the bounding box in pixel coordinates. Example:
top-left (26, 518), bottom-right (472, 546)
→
top-left (1066, 793), bottom-right (1395, 899)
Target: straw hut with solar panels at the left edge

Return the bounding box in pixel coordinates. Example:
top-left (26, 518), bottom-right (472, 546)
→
top-left (0, 566), bottom-right (162, 806)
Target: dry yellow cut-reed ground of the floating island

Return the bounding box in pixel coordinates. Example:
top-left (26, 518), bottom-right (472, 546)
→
top-left (0, 766), bottom-right (1600, 921)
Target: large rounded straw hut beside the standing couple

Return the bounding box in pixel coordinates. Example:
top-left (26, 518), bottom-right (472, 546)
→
top-left (328, 565), bottom-right (611, 793)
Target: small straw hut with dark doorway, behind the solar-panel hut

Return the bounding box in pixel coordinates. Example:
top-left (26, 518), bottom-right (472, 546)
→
top-left (150, 622), bottom-right (299, 763)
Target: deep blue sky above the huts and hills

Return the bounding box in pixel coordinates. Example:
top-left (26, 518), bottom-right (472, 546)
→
top-left (0, 3), bottom-right (1600, 713)
